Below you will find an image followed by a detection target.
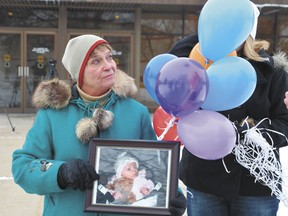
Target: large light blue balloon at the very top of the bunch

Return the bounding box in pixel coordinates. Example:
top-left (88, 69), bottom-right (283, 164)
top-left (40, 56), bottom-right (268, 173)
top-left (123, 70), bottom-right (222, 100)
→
top-left (198, 0), bottom-right (254, 61)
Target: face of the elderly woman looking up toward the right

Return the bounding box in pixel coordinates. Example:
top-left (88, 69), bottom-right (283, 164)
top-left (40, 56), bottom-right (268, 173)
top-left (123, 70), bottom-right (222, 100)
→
top-left (81, 46), bottom-right (117, 96)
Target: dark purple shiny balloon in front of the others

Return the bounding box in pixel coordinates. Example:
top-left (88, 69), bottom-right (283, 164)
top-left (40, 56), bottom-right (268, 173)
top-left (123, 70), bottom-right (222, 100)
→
top-left (155, 57), bottom-right (208, 117)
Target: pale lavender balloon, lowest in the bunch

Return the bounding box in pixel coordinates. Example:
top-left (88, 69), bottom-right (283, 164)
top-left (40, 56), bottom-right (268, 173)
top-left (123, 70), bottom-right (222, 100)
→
top-left (177, 110), bottom-right (236, 160)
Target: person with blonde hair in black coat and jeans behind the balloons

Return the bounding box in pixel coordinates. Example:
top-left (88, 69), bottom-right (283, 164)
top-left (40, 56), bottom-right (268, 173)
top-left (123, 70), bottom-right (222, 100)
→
top-left (169, 5), bottom-right (288, 216)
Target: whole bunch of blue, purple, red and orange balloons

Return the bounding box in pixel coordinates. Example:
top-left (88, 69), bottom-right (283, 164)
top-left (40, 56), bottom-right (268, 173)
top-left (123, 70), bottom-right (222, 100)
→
top-left (144, 0), bottom-right (256, 160)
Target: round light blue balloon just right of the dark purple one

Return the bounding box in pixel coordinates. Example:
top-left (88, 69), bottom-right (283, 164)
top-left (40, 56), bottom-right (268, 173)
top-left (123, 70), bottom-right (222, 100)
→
top-left (201, 56), bottom-right (257, 111)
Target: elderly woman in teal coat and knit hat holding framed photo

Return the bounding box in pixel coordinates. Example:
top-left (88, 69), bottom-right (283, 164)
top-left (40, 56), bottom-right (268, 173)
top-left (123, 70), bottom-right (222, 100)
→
top-left (12, 35), bottom-right (185, 216)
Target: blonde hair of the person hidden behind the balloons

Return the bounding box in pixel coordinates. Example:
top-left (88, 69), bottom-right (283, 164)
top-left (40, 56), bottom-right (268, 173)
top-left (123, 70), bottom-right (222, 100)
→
top-left (243, 35), bottom-right (270, 61)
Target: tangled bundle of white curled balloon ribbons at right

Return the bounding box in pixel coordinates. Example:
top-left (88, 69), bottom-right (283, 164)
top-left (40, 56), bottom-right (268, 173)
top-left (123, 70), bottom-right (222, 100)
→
top-left (233, 118), bottom-right (288, 206)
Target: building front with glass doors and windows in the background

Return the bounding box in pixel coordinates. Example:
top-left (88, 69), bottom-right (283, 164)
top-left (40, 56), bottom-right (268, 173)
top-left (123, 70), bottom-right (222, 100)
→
top-left (0, 0), bottom-right (288, 113)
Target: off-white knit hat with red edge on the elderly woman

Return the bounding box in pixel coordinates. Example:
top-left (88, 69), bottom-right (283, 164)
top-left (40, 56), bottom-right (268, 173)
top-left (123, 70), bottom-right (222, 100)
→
top-left (62, 35), bottom-right (108, 87)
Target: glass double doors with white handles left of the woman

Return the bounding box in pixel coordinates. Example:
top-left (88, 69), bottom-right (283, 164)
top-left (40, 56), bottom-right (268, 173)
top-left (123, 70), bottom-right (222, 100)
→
top-left (0, 31), bottom-right (58, 113)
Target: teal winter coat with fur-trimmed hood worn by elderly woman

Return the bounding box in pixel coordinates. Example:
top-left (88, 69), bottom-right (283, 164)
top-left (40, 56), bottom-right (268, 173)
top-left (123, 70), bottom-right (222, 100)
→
top-left (12, 71), bottom-right (156, 216)
